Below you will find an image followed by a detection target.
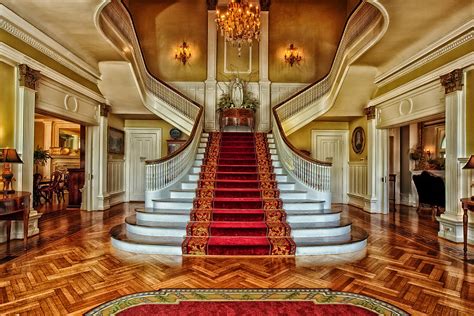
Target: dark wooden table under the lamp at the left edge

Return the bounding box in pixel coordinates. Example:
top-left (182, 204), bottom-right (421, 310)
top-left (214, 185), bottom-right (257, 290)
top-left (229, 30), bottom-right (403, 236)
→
top-left (0, 191), bottom-right (31, 249)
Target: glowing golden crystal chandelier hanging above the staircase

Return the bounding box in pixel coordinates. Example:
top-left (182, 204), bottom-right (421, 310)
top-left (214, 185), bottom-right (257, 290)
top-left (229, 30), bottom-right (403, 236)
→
top-left (216, 0), bottom-right (260, 56)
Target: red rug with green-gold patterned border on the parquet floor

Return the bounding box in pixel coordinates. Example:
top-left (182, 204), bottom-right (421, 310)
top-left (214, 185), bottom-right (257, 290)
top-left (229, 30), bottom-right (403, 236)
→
top-left (85, 289), bottom-right (409, 316)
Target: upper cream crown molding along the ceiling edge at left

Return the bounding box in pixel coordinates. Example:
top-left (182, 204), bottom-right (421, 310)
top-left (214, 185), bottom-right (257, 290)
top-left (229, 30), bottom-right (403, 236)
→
top-left (0, 4), bottom-right (100, 84)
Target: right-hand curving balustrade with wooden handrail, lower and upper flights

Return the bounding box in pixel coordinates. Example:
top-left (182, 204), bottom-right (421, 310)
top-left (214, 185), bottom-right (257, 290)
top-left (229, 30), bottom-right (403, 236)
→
top-left (272, 2), bottom-right (382, 192)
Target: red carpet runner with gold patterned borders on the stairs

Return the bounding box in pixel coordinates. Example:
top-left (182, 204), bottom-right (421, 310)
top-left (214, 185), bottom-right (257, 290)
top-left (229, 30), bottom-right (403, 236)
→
top-left (182, 132), bottom-right (296, 255)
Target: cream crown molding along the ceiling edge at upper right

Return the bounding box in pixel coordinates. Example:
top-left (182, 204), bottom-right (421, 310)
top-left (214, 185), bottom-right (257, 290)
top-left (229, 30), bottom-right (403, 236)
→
top-left (374, 20), bottom-right (474, 86)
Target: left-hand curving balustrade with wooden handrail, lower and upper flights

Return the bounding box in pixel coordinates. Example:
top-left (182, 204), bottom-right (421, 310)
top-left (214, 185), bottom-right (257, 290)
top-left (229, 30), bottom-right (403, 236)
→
top-left (99, 0), bottom-right (204, 191)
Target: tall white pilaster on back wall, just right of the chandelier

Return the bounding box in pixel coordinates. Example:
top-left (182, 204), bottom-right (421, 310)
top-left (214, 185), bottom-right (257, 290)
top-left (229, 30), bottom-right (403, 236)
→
top-left (257, 8), bottom-right (271, 132)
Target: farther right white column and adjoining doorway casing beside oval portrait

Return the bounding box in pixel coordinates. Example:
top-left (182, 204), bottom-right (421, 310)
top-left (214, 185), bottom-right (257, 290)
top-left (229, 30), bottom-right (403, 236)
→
top-left (364, 107), bottom-right (388, 214)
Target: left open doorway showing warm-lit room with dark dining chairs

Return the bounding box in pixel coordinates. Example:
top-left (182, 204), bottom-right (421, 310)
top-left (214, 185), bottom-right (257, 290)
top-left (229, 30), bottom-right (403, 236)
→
top-left (33, 113), bottom-right (85, 213)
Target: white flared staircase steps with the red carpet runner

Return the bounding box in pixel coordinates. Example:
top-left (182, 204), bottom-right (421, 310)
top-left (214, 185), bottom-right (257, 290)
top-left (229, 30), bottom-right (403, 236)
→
top-left (111, 133), bottom-right (367, 255)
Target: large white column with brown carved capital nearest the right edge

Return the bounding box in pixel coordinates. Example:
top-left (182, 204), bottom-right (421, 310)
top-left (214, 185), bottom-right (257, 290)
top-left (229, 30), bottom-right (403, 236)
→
top-left (438, 69), bottom-right (470, 242)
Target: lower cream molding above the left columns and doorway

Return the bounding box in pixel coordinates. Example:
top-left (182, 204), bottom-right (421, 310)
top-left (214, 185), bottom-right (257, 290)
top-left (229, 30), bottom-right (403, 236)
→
top-left (0, 43), bottom-right (105, 103)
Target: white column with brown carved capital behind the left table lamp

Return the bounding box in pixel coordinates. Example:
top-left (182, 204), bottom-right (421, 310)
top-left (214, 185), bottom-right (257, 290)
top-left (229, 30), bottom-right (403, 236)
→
top-left (12, 64), bottom-right (41, 238)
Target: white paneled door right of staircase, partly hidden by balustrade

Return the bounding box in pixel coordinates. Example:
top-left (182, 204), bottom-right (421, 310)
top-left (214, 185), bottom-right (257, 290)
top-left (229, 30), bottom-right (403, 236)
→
top-left (311, 130), bottom-right (349, 203)
